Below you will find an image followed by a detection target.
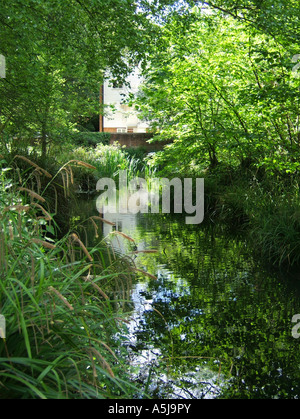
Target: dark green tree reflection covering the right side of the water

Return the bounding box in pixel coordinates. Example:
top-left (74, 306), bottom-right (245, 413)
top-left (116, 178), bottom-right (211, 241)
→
top-left (129, 217), bottom-right (300, 398)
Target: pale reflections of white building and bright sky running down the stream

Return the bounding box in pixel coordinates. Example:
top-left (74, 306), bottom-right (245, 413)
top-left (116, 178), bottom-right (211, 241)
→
top-left (103, 213), bottom-right (227, 399)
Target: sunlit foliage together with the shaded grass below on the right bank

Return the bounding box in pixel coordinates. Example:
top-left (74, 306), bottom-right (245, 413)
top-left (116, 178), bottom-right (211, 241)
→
top-left (129, 0), bottom-right (300, 266)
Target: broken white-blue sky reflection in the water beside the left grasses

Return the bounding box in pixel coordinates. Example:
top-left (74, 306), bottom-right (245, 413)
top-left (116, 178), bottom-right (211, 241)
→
top-left (119, 256), bottom-right (223, 399)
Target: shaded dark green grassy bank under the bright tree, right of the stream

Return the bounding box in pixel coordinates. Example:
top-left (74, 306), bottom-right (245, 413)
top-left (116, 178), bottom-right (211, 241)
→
top-left (200, 166), bottom-right (300, 268)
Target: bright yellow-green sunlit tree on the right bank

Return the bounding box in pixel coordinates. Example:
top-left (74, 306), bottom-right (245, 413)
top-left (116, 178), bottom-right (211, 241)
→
top-left (133, 8), bottom-right (300, 176)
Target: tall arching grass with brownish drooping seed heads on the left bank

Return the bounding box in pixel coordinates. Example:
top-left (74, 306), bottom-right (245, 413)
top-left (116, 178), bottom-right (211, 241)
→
top-left (0, 159), bottom-right (139, 399)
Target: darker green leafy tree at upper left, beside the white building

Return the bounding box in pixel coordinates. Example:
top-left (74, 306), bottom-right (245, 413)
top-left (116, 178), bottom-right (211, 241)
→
top-left (0, 0), bottom-right (183, 156)
